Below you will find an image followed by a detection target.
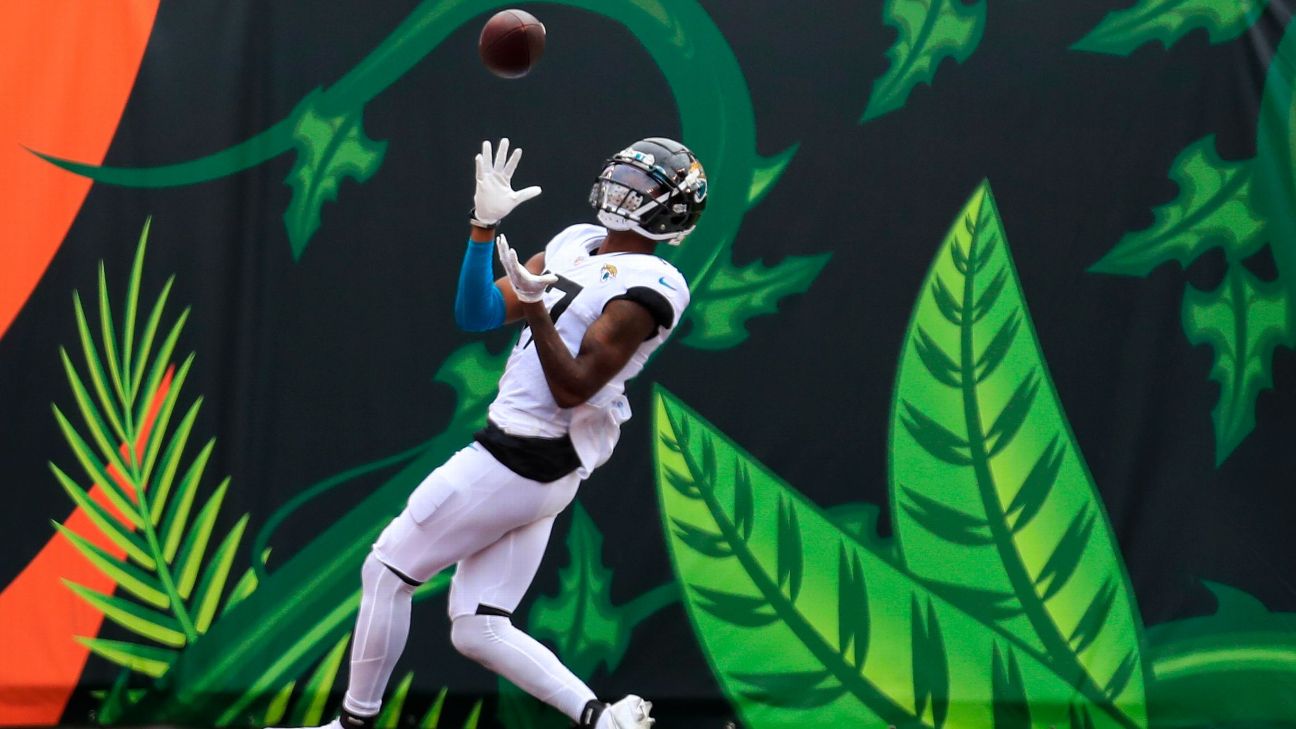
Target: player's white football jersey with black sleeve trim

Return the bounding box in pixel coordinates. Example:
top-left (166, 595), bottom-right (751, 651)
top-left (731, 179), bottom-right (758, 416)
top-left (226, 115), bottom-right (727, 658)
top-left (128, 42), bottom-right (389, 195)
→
top-left (490, 224), bottom-right (688, 477)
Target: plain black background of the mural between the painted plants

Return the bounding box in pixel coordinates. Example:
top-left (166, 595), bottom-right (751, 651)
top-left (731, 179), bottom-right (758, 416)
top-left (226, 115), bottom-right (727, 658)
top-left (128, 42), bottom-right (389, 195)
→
top-left (0, 0), bottom-right (1296, 725)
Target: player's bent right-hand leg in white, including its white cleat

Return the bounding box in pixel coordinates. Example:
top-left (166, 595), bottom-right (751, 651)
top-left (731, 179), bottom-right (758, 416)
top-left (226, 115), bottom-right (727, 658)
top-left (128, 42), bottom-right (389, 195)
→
top-left (450, 505), bottom-right (652, 729)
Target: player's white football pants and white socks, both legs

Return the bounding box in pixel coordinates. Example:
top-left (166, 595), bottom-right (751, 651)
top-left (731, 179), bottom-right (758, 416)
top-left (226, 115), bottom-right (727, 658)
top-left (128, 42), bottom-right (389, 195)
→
top-left (343, 442), bottom-right (595, 720)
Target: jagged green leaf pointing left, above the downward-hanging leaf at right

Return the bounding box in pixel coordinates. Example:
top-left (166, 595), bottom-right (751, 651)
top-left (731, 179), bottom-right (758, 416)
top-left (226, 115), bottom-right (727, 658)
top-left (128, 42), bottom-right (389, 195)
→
top-left (1090, 135), bottom-right (1266, 276)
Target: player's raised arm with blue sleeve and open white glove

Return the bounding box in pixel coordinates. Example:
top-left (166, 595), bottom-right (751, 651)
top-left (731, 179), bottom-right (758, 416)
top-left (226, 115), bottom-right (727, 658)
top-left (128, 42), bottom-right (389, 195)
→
top-left (455, 139), bottom-right (544, 332)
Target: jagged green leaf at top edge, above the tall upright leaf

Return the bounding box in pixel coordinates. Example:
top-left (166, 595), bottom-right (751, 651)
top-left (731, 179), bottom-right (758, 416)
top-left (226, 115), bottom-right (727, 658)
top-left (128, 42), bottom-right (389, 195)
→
top-left (859, 0), bottom-right (986, 122)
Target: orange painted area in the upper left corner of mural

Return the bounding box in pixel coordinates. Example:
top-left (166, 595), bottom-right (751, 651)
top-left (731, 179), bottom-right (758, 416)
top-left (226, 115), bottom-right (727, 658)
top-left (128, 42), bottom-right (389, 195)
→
top-left (0, 0), bottom-right (158, 337)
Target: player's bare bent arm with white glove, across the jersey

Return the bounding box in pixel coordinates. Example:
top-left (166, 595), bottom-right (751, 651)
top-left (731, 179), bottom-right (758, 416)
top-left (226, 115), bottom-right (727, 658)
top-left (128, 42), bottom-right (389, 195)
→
top-left (495, 236), bottom-right (657, 407)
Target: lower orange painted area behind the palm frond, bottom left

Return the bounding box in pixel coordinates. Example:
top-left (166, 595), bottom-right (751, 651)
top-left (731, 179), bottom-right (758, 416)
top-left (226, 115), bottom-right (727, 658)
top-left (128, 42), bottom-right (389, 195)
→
top-left (0, 367), bottom-right (175, 726)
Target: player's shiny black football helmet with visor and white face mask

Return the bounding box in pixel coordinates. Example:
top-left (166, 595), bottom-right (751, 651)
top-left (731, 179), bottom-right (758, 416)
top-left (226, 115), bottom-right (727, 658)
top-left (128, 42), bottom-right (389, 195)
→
top-left (590, 136), bottom-right (706, 245)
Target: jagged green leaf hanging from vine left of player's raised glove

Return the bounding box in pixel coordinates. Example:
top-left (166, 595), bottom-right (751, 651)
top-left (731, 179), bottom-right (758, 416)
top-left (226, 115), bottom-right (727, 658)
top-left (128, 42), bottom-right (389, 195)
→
top-left (284, 88), bottom-right (388, 258)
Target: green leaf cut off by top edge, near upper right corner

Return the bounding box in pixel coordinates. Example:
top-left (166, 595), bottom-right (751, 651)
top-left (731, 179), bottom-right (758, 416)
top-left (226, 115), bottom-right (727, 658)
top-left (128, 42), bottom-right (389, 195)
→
top-left (1072, 0), bottom-right (1269, 56)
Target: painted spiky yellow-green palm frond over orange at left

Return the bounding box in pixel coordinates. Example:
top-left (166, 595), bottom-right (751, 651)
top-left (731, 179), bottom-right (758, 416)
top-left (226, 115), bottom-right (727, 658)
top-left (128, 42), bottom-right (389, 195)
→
top-left (49, 222), bottom-right (248, 677)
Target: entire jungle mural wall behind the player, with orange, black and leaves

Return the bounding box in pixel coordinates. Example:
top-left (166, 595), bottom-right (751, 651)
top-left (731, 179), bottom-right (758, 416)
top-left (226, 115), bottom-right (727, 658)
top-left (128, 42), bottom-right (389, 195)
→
top-left (0, 0), bottom-right (1296, 729)
